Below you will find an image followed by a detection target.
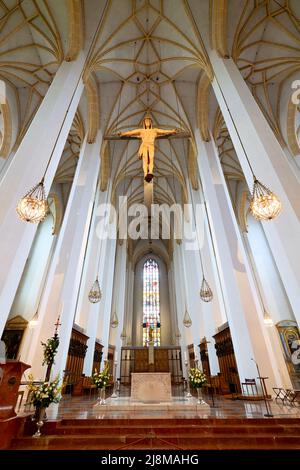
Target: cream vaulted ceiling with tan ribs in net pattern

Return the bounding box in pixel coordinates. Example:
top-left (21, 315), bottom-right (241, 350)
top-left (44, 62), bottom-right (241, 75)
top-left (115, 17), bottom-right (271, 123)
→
top-left (0, 0), bottom-right (300, 250)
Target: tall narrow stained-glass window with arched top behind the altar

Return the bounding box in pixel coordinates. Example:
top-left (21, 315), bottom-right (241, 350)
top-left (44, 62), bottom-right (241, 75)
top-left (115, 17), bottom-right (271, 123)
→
top-left (143, 258), bottom-right (160, 346)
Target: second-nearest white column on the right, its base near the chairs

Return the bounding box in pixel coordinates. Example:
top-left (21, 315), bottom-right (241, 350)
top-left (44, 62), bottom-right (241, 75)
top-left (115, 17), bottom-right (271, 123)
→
top-left (196, 130), bottom-right (283, 387)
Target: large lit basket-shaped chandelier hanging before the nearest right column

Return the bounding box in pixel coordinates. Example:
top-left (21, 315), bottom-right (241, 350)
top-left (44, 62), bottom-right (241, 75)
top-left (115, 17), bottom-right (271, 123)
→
top-left (250, 177), bottom-right (282, 220)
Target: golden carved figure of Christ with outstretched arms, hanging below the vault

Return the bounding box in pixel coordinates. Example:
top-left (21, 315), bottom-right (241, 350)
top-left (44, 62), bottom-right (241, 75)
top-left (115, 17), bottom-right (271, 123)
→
top-left (120, 117), bottom-right (180, 183)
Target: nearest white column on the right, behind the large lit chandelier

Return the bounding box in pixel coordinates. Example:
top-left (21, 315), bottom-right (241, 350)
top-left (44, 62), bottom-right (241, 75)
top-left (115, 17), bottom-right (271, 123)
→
top-left (210, 51), bottom-right (300, 325)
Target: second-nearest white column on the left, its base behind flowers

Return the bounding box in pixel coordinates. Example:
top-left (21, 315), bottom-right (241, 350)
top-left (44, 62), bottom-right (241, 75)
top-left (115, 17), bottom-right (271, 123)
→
top-left (29, 131), bottom-right (102, 377)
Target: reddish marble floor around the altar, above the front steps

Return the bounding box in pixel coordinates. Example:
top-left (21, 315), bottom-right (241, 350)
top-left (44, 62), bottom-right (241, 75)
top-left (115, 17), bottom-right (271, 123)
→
top-left (19, 394), bottom-right (300, 421)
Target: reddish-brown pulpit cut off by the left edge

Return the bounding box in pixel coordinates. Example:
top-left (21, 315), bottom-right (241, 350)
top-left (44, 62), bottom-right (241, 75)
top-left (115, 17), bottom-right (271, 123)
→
top-left (0, 361), bottom-right (30, 419)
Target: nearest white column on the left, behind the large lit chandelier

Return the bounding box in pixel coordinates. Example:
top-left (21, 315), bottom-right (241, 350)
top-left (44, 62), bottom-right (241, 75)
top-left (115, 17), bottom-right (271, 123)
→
top-left (0, 54), bottom-right (84, 333)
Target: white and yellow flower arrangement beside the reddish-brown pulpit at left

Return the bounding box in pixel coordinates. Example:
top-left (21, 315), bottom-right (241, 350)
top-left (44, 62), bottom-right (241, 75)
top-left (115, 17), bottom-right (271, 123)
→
top-left (28, 375), bottom-right (64, 408)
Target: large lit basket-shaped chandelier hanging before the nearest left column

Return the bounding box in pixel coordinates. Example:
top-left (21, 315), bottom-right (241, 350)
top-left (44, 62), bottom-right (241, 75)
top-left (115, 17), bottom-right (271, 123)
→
top-left (16, 178), bottom-right (49, 224)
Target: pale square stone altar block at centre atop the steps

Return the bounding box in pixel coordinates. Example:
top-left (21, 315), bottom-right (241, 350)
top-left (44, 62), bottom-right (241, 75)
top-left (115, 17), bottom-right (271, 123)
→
top-left (131, 372), bottom-right (172, 403)
